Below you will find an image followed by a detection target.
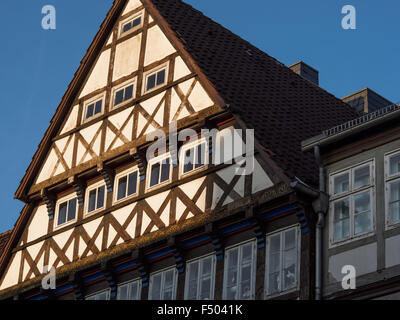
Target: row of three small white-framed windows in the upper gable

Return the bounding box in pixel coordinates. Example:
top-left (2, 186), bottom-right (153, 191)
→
top-left (84, 66), bottom-right (167, 121)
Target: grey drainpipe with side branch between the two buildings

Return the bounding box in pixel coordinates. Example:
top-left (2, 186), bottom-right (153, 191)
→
top-left (290, 146), bottom-right (329, 300)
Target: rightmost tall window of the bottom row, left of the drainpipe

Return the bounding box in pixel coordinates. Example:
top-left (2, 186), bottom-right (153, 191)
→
top-left (265, 227), bottom-right (300, 297)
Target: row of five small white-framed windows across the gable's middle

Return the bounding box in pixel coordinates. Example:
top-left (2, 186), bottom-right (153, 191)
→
top-left (56, 140), bottom-right (208, 226)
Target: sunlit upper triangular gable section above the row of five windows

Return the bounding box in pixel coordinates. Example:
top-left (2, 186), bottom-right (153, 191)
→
top-left (16, 0), bottom-right (225, 199)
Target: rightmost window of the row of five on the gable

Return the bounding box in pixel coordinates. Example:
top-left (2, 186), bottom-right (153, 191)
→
top-left (181, 139), bottom-right (208, 174)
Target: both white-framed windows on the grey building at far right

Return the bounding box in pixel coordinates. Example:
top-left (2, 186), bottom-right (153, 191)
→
top-left (330, 152), bottom-right (400, 243)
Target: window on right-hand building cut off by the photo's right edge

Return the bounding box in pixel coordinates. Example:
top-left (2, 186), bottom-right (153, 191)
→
top-left (385, 152), bottom-right (400, 226)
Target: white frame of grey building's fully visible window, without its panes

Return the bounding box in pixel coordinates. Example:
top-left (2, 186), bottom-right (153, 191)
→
top-left (329, 159), bottom-right (376, 248)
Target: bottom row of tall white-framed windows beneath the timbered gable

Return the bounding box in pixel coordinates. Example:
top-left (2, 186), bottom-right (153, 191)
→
top-left (86, 227), bottom-right (300, 300)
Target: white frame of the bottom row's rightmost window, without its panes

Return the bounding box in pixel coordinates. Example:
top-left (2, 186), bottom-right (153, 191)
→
top-left (264, 224), bottom-right (301, 299)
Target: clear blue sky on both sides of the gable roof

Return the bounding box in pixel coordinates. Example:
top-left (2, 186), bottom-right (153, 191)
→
top-left (0, 0), bottom-right (400, 232)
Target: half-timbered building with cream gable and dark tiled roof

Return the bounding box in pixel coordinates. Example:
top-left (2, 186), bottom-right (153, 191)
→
top-left (0, 0), bottom-right (356, 300)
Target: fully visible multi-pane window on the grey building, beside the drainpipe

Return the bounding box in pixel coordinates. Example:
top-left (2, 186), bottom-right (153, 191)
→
top-left (330, 161), bottom-right (374, 243)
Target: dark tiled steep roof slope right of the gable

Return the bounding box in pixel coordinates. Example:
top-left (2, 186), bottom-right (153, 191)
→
top-left (151, 0), bottom-right (357, 183)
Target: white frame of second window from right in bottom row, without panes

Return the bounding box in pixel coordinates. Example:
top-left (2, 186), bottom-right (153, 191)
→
top-left (222, 239), bottom-right (257, 300)
